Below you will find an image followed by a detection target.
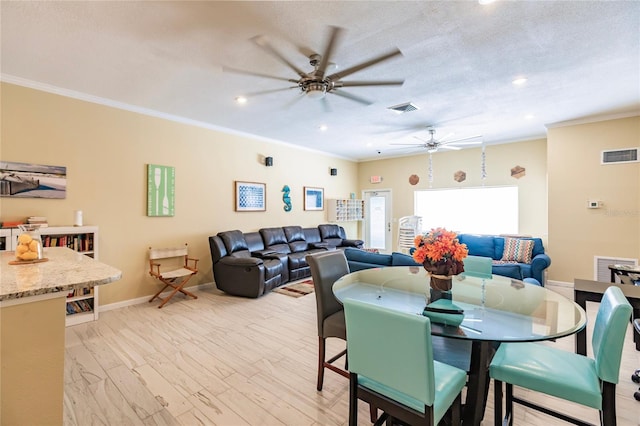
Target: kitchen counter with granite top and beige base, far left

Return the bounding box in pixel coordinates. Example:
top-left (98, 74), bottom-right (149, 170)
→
top-left (0, 247), bottom-right (122, 426)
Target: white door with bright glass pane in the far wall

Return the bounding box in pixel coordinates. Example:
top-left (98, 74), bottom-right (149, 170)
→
top-left (364, 190), bottom-right (393, 253)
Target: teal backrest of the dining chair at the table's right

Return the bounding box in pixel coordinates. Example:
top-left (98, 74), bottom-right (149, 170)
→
top-left (591, 286), bottom-right (632, 384)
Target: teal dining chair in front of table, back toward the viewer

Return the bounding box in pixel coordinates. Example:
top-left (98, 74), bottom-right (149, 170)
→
top-left (344, 299), bottom-right (467, 426)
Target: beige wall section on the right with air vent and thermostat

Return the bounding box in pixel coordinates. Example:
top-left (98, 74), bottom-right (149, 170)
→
top-left (547, 117), bottom-right (640, 282)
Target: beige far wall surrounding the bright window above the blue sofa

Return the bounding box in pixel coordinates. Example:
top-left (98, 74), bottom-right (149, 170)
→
top-left (358, 139), bottom-right (547, 240)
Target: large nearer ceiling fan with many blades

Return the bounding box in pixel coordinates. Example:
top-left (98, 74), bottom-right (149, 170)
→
top-left (223, 26), bottom-right (404, 108)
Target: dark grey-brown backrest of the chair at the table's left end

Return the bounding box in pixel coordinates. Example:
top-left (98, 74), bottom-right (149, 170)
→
top-left (306, 250), bottom-right (349, 336)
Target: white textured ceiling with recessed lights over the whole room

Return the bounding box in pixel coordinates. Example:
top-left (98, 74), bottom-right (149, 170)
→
top-left (0, 1), bottom-right (640, 160)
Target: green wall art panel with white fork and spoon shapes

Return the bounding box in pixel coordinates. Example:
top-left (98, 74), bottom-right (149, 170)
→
top-left (147, 164), bottom-right (176, 216)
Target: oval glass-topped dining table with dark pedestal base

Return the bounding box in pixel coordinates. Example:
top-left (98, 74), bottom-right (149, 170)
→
top-left (333, 266), bottom-right (586, 425)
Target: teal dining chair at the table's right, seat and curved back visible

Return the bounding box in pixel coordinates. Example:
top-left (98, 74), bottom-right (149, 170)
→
top-left (489, 286), bottom-right (631, 426)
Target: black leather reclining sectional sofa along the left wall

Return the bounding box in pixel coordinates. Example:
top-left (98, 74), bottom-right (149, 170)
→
top-left (209, 224), bottom-right (363, 298)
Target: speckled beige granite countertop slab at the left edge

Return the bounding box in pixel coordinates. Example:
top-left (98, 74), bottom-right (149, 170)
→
top-left (0, 247), bottom-right (122, 302)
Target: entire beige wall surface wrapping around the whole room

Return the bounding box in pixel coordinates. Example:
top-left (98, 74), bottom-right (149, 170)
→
top-left (0, 84), bottom-right (640, 304)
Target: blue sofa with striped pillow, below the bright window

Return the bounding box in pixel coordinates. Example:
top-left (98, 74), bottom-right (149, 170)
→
top-left (458, 234), bottom-right (551, 287)
